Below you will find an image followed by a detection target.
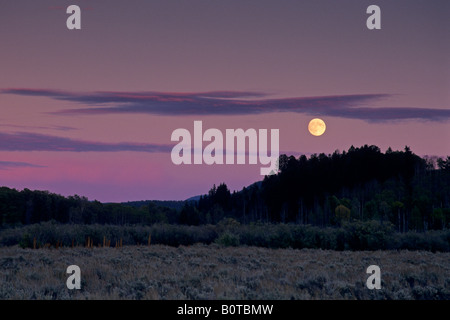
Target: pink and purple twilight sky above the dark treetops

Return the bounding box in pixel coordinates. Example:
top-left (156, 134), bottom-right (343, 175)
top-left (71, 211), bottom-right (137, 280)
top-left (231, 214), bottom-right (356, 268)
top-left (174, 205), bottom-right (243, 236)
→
top-left (0, 0), bottom-right (450, 201)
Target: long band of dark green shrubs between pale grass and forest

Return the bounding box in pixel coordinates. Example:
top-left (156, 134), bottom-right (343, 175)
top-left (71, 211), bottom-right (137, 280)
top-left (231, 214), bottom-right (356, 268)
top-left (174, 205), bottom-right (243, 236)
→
top-left (0, 219), bottom-right (450, 252)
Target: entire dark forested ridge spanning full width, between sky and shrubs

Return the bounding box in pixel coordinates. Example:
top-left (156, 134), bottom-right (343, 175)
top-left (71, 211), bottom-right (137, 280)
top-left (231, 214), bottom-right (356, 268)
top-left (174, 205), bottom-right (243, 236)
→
top-left (0, 145), bottom-right (450, 232)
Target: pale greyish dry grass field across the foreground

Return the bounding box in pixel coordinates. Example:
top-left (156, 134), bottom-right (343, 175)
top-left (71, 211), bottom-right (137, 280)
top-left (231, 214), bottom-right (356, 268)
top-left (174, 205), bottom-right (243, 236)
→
top-left (0, 245), bottom-right (450, 299)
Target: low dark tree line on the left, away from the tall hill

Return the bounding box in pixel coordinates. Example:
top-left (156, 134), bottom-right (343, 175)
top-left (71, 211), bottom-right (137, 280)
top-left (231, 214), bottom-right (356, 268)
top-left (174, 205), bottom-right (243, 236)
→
top-left (0, 187), bottom-right (179, 227)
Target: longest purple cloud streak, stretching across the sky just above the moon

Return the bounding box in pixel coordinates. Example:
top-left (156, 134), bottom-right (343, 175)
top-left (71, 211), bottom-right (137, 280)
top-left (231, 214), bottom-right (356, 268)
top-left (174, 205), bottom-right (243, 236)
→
top-left (0, 89), bottom-right (450, 122)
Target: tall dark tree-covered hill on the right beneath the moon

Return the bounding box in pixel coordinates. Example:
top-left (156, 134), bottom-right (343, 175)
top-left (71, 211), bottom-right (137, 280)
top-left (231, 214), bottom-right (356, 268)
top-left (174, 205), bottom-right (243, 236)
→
top-left (196, 145), bottom-right (450, 232)
